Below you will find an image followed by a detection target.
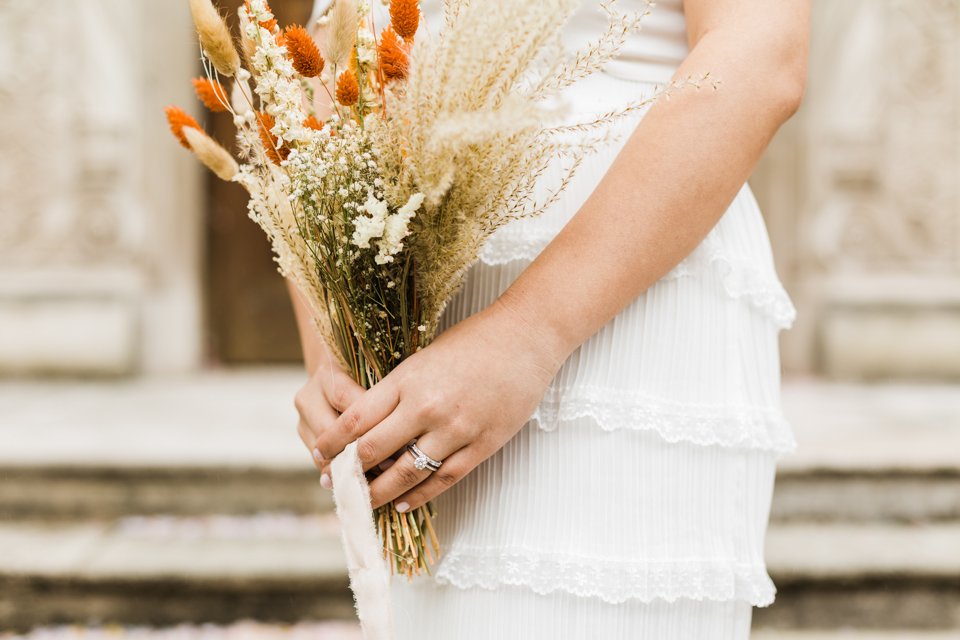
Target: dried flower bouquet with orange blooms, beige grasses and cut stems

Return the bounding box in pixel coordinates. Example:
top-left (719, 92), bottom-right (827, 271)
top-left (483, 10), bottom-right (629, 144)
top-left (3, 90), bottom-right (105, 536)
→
top-left (167, 0), bottom-right (706, 576)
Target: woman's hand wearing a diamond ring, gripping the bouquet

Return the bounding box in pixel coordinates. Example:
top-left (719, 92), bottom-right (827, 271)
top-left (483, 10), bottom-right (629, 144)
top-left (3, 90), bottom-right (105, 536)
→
top-left (316, 298), bottom-right (566, 512)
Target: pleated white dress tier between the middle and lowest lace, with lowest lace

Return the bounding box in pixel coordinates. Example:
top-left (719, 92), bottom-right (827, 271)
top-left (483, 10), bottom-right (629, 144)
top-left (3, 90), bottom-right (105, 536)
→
top-left (420, 420), bottom-right (774, 605)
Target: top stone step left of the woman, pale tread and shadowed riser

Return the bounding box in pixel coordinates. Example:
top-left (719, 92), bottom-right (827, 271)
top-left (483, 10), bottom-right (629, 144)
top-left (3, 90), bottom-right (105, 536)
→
top-left (0, 368), bottom-right (331, 520)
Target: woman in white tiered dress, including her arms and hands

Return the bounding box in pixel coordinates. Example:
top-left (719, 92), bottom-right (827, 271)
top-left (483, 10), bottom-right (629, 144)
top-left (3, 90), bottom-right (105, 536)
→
top-left (294, 0), bottom-right (810, 640)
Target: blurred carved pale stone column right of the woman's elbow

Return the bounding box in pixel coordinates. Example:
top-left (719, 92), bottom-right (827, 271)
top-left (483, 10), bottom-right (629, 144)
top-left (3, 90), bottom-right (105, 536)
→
top-left (751, 0), bottom-right (960, 378)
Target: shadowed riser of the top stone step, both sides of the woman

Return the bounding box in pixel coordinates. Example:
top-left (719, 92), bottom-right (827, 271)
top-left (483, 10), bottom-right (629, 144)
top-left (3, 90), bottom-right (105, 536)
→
top-left (0, 461), bottom-right (960, 523)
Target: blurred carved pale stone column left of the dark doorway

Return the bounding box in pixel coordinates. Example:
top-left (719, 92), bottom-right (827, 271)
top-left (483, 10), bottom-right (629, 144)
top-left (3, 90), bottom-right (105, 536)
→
top-left (0, 0), bottom-right (202, 374)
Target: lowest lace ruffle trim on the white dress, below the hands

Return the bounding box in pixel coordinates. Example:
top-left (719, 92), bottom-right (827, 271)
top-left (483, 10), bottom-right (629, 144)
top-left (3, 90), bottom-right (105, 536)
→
top-left (436, 548), bottom-right (776, 607)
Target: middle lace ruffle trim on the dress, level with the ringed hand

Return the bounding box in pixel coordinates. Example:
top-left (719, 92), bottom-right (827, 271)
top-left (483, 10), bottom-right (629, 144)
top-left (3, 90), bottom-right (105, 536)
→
top-left (530, 387), bottom-right (797, 454)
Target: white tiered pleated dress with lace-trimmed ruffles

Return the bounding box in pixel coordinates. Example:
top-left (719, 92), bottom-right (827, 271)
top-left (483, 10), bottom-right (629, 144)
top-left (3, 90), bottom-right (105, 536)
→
top-left (317, 0), bottom-right (795, 640)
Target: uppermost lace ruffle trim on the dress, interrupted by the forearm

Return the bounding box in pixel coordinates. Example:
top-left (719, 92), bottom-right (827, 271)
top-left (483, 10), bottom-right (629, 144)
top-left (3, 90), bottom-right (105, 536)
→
top-left (480, 229), bottom-right (797, 329)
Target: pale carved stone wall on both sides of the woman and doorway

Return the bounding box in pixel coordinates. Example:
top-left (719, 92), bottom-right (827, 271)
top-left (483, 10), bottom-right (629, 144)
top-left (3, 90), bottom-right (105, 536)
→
top-left (0, 0), bottom-right (960, 377)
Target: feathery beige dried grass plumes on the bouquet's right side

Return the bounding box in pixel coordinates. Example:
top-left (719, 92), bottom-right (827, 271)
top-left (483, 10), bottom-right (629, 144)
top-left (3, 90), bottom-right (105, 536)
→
top-left (373, 0), bottom-right (672, 322)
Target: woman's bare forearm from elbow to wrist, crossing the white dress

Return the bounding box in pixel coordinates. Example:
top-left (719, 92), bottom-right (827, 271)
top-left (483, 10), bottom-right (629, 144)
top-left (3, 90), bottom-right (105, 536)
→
top-left (495, 23), bottom-right (805, 358)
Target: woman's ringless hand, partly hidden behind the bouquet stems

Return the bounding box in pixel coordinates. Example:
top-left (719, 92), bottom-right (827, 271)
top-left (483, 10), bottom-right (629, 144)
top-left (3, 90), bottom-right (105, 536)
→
top-left (293, 348), bottom-right (364, 489)
